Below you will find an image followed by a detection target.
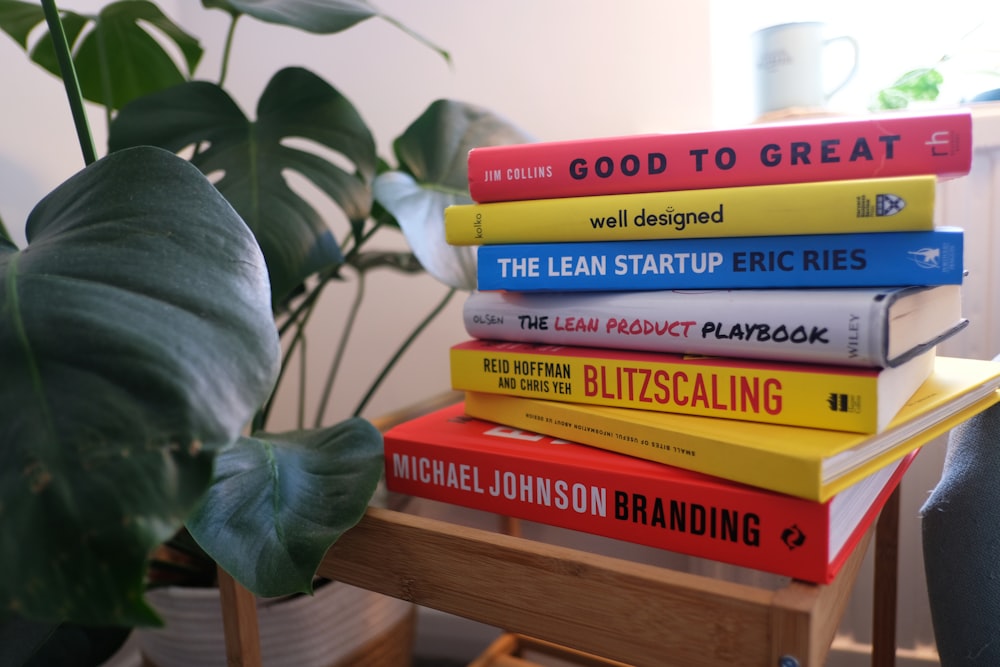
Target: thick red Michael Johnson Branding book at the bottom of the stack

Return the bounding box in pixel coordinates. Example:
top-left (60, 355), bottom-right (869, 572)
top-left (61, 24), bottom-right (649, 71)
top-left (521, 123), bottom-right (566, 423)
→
top-left (385, 403), bottom-right (919, 583)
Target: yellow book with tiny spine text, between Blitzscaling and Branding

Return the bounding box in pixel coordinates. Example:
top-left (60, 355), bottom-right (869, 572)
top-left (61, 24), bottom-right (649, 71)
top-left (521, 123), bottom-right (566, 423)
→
top-left (465, 357), bottom-right (1000, 502)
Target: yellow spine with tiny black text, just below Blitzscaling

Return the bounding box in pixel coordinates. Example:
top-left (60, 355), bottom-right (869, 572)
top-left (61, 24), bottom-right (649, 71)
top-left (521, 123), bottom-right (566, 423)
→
top-left (465, 391), bottom-right (831, 502)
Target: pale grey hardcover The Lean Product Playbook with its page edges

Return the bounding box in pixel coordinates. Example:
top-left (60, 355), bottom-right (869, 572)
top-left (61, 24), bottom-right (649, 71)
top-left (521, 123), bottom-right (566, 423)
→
top-left (462, 285), bottom-right (968, 367)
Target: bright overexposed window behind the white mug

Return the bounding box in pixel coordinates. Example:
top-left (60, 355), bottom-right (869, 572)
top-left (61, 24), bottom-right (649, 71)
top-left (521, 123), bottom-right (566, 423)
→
top-left (710, 0), bottom-right (1000, 126)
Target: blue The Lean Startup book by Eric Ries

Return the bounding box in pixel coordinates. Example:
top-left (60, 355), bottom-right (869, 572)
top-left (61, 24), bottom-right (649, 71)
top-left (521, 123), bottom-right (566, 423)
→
top-left (477, 227), bottom-right (965, 292)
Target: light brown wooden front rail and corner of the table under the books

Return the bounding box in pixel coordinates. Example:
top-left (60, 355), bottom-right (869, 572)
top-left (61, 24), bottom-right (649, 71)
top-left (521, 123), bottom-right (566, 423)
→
top-left (320, 508), bottom-right (872, 667)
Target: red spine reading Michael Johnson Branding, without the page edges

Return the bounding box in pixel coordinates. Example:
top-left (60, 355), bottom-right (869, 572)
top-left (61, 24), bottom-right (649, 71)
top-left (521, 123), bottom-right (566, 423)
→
top-left (385, 427), bottom-right (829, 582)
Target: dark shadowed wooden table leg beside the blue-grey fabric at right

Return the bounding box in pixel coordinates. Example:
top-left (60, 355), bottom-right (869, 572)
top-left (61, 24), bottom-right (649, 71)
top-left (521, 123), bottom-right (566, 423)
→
top-left (872, 487), bottom-right (899, 667)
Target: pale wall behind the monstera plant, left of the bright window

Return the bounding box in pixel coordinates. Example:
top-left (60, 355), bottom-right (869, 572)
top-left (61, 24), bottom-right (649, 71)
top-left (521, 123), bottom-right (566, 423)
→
top-left (0, 0), bottom-right (710, 424)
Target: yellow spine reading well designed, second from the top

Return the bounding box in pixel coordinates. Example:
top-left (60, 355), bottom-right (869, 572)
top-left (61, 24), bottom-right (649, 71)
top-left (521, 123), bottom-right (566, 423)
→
top-left (444, 176), bottom-right (936, 245)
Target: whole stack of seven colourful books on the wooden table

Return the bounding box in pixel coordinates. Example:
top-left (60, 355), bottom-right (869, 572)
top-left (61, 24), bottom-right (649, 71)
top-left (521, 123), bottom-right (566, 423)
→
top-left (385, 110), bottom-right (1000, 583)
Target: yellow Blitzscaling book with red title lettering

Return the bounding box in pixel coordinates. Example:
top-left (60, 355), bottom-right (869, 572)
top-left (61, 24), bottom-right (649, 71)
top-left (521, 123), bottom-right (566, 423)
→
top-left (450, 339), bottom-right (935, 433)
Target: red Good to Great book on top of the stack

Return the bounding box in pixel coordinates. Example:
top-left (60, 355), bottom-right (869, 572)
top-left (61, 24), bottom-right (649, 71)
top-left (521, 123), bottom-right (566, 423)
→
top-left (468, 109), bottom-right (973, 203)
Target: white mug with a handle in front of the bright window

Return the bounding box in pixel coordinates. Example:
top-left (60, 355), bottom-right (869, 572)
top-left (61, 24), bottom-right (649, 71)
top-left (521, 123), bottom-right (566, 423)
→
top-left (754, 22), bottom-right (858, 114)
